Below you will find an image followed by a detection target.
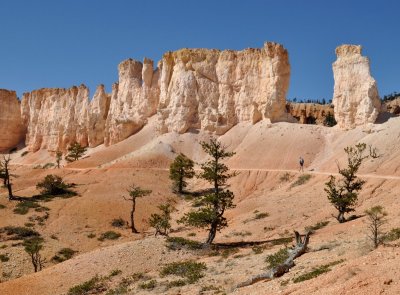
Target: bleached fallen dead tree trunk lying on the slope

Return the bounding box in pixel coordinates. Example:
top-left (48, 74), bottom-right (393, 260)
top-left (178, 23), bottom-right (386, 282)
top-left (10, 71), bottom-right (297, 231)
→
top-left (236, 231), bottom-right (310, 288)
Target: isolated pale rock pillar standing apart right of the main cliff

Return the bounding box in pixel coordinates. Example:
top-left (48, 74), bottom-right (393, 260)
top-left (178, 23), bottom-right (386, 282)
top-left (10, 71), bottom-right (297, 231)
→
top-left (332, 45), bottom-right (381, 129)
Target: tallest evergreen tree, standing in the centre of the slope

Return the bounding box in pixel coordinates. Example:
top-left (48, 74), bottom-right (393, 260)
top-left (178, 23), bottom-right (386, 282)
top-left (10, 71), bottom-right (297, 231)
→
top-left (179, 138), bottom-right (236, 244)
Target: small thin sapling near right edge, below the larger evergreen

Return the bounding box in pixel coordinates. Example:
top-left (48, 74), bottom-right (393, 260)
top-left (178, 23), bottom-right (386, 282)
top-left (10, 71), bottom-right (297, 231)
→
top-left (365, 206), bottom-right (387, 248)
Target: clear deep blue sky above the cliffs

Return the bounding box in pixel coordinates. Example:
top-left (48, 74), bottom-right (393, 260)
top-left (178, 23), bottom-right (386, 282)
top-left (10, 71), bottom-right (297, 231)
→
top-left (0, 0), bottom-right (400, 99)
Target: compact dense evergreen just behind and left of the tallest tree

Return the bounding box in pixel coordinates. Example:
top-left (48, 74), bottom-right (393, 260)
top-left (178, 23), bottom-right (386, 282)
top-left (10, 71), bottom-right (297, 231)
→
top-left (169, 153), bottom-right (195, 194)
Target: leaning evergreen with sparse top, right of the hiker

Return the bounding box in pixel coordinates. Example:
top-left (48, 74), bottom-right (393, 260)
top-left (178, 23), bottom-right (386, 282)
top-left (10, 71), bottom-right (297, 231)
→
top-left (325, 143), bottom-right (368, 223)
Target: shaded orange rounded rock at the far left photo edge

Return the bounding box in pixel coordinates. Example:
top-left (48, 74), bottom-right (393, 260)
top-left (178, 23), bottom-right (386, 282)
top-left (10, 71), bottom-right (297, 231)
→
top-left (0, 89), bottom-right (24, 152)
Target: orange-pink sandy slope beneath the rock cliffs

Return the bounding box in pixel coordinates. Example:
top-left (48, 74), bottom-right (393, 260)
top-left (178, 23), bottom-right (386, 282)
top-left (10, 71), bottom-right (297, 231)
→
top-left (0, 117), bottom-right (400, 294)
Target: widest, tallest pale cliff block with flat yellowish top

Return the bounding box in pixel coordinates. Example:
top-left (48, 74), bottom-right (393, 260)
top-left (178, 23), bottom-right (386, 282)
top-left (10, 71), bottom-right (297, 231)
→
top-left (158, 42), bottom-right (290, 134)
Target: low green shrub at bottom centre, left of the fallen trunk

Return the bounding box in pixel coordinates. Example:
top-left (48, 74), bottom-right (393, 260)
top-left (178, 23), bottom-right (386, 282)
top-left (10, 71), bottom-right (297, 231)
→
top-left (160, 261), bottom-right (207, 284)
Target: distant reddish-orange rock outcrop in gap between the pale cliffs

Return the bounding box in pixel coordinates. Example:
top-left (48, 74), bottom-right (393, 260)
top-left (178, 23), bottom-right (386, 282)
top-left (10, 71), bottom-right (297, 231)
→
top-left (286, 102), bottom-right (334, 125)
